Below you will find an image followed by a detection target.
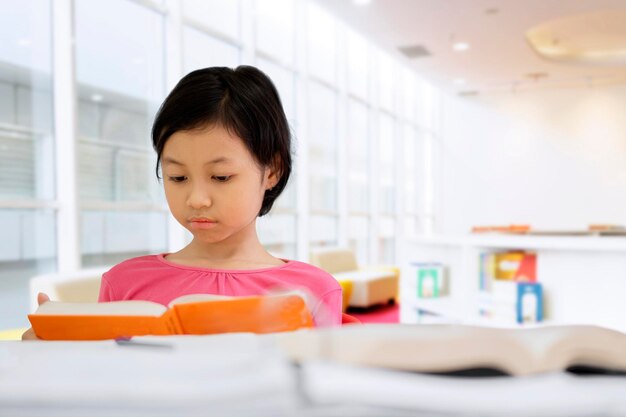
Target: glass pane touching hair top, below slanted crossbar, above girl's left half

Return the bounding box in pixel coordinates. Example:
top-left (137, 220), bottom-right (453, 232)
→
top-left (183, 27), bottom-right (239, 74)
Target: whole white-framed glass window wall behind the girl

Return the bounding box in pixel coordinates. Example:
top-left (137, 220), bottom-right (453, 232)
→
top-left (0, 0), bottom-right (443, 328)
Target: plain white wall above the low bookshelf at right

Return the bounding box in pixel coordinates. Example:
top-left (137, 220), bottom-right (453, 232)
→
top-left (436, 86), bottom-right (626, 234)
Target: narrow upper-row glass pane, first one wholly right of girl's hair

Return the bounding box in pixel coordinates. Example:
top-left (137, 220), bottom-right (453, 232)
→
top-left (307, 3), bottom-right (337, 85)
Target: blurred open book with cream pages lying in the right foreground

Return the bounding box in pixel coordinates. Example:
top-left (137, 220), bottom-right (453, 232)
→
top-left (276, 324), bottom-right (626, 376)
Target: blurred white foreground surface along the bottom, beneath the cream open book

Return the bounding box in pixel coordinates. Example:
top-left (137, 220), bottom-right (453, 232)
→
top-left (0, 334), bottom-right (626, 417)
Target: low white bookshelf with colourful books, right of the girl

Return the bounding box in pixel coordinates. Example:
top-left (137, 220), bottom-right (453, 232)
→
top-left (400, 234), bottom-right (626, 331)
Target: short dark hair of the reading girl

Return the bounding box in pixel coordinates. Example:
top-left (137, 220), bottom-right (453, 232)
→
top-left (152, 65), bottom-right (291, 216)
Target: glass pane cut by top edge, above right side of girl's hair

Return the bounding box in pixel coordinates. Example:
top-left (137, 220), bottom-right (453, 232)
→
top-left (255, 0), bottom-right (295, 65)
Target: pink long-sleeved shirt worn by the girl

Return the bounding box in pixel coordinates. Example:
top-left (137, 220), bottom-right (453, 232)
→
top-left (98, 254), bottom-right (342, 326)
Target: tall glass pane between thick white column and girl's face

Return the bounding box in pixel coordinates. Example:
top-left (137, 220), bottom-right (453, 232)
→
top-left (75, 0), bottom-right (167, 266)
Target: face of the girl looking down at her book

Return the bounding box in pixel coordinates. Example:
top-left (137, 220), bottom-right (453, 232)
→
top-left (161, 125), bottom-right (278, 243)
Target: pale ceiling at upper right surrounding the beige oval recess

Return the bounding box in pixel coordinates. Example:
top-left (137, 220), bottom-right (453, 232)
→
top-left (315, 0), bottom-right (626, 95)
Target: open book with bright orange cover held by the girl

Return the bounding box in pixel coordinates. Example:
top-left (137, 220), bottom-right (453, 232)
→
top-left (28, 293), bottom-right (313, 340)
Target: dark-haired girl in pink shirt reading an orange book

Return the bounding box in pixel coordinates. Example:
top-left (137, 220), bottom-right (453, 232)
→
top-left (25, 66), bottom-right (342, 336)
